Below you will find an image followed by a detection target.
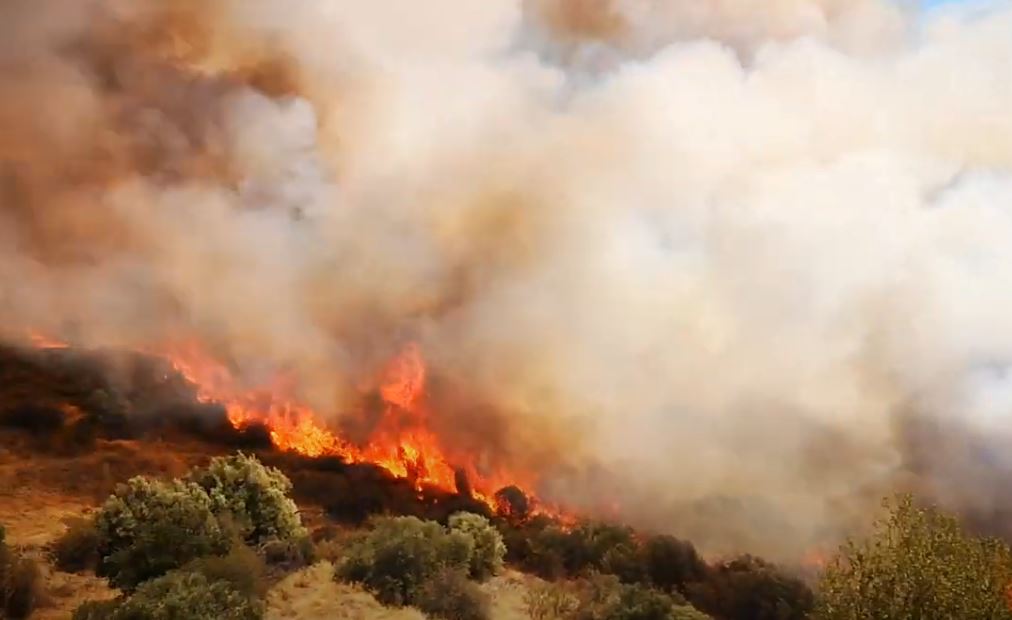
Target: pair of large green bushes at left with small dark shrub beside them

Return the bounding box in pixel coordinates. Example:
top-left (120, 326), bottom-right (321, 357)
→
top-left (90, 453), bottom-right (308, 591)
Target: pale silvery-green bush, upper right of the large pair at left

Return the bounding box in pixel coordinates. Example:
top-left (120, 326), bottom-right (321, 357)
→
top-left (187, 452), bottom-right (308, 544)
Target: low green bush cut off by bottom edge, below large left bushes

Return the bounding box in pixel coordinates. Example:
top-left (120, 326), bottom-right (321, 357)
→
top-left (74, 570), bottom-right (264, 620)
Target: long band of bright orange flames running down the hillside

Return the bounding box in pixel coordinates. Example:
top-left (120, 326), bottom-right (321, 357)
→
top-left (167, 343), bottom-right (559, 507)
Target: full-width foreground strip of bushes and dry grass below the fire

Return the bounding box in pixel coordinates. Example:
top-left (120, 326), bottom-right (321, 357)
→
top-left (0, 432), bottom-right (1012, 620)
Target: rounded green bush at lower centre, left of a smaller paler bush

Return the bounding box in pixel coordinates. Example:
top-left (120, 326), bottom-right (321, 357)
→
top-left (335, 517), bottom-right (474, 605)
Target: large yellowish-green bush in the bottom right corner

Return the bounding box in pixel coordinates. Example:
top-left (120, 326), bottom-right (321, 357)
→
top-left (817, 496), bottom-right (1012, 620)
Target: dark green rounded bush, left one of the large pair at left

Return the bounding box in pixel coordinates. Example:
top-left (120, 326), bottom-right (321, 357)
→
top-left (95, 476), bottom-right (231, 590)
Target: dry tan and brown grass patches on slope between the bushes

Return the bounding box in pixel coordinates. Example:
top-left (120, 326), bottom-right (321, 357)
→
top-left (0, 431), bottom-right (550, 620)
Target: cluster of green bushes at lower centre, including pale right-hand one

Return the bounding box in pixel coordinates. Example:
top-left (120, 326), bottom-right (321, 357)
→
top-left (336, 514), bottom-right (506, 620)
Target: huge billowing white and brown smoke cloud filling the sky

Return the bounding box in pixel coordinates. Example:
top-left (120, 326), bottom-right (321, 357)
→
top-left (0, 0), bottom-right (1012, 549)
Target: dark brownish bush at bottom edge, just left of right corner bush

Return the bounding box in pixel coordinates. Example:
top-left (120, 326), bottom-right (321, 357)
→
top-left (686, 555), bottom-right (815, 620)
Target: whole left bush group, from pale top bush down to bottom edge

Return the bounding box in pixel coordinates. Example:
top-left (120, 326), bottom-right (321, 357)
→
top-left (71, 454), bottom-right (301, 620)
